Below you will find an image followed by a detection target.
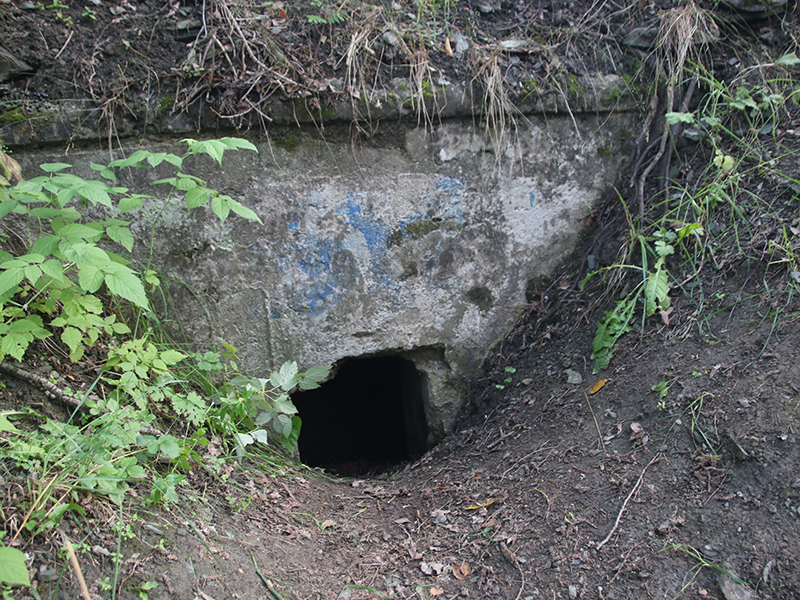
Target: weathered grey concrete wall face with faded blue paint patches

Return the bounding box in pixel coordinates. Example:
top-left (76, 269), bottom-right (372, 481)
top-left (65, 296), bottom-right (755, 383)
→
top-left (18, 114), bottom-right (634, 442)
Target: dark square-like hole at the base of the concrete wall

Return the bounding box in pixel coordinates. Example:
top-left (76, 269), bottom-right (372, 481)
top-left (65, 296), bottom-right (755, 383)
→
top-left (292, 356), bottom-right (428, 475)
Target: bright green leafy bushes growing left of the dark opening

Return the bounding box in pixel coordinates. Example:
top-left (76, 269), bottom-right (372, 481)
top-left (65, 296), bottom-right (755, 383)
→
top-left (0, 138), bottom-right (327, 540)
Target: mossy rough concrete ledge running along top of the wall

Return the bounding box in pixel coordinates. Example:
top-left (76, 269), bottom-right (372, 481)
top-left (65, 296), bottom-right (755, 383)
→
top-left (0, 73), bottom-right (638, 148)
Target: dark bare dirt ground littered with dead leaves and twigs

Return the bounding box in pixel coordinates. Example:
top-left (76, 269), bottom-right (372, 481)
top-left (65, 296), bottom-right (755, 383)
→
top-left (0, 2), bottom-right (800, 600)
